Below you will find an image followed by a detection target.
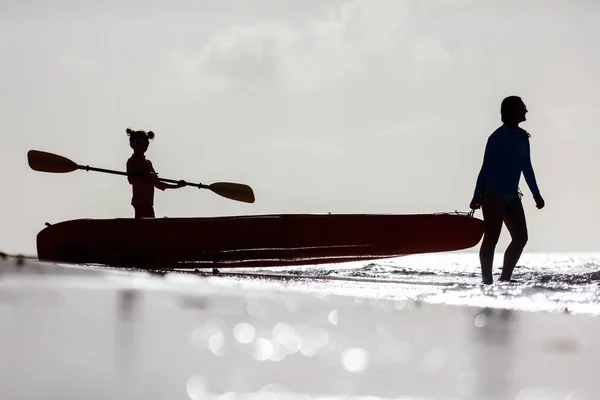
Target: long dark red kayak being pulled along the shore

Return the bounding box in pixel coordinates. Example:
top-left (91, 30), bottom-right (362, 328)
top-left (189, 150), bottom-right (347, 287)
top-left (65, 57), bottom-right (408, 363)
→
top-left (37, 213), bottom-right (483, 269)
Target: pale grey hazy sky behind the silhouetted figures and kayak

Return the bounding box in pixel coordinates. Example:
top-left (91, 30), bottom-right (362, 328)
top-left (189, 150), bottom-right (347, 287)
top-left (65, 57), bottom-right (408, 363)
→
top-left (0, 0), bottom-right (600, 254)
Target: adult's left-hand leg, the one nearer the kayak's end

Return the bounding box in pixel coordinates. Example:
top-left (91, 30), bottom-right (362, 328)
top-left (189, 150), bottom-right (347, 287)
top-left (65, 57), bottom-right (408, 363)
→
top-left (479, 193), bottom-right (506, 285)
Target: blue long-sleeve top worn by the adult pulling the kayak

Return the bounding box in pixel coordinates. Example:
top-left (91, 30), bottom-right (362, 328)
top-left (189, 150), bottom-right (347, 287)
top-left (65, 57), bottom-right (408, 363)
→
top-left (474, 124), bottom-right (540, 197)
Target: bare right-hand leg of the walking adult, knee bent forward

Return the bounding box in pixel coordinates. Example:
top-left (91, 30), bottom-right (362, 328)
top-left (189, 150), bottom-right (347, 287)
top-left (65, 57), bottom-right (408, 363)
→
top-left (500, 198), bottom-right (529, 281)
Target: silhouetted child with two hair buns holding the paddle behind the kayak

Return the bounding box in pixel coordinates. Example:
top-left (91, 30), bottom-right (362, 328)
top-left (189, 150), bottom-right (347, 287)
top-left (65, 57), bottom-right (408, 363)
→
top-left (126, 128), bottom-right (186, 218)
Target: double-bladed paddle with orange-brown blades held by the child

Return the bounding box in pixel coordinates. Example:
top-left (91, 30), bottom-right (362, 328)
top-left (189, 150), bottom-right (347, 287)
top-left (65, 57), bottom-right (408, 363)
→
top-left (27, 150), bottom-right (254, 203)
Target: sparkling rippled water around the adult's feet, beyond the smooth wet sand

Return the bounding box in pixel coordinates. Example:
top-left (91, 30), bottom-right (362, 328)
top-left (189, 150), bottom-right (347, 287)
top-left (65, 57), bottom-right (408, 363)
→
top-left (189, 253), bottom-right (600, 315)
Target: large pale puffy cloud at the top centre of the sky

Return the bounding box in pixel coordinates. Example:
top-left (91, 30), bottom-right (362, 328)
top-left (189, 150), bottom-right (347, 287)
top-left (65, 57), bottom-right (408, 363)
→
top-left (166, 0), bottom-right (451, 92)
